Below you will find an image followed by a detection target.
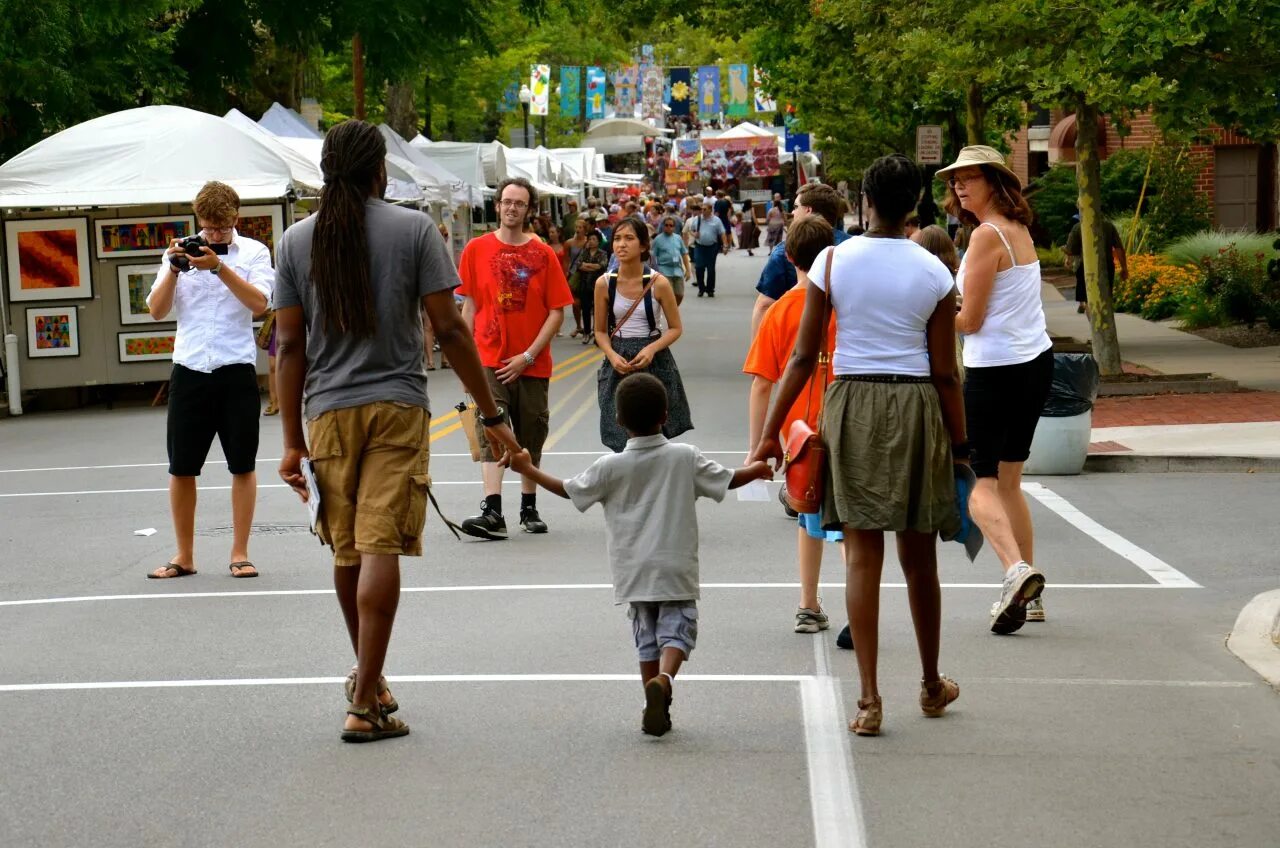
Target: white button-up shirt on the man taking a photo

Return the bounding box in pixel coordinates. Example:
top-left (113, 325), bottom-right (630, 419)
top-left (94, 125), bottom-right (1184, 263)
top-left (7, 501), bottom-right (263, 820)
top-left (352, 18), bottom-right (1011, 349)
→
top-left (147, 232), bottom-right (275, 374)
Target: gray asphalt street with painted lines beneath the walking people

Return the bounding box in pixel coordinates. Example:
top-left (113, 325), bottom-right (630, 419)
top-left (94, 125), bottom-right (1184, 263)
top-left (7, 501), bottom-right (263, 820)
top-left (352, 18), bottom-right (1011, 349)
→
top-left (0, 254), bottom-right (1280, 848)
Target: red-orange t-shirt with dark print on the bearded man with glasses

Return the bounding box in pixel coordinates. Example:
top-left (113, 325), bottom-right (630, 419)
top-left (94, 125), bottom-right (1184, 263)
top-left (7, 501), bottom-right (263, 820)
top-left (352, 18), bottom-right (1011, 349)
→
top-left (458, 233), bottom-right (573, 377)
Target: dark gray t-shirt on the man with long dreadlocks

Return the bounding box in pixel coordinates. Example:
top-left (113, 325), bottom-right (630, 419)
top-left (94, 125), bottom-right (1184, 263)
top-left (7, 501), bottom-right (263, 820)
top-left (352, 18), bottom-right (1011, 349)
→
top-left (274, 197), bottom-right (461, 419)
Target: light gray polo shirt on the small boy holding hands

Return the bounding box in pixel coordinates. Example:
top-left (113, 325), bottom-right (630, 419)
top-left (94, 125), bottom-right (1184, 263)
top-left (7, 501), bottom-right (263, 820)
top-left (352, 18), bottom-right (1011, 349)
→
top-left (564, 434), bottom-right (733, 603)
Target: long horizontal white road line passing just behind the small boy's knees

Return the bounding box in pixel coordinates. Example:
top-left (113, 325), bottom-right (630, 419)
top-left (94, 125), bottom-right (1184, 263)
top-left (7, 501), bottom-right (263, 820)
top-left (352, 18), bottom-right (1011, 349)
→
top-left (0, 583), bottom-right (1183, 607)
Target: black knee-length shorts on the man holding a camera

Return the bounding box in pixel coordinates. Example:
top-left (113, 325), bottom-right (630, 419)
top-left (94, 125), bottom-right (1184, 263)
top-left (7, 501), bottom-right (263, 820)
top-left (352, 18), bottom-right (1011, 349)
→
top-left (168, 365), bottom-right (261, 477)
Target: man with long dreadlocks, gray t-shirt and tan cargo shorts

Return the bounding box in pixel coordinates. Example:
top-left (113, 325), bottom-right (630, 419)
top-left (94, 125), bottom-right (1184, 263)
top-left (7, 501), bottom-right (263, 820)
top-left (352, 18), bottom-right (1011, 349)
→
top-left (275, 120), bottom-right (520, 742)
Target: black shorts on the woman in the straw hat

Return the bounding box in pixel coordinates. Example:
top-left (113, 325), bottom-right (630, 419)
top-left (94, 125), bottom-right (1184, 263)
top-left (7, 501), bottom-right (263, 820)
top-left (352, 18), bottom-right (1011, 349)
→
top-left (964, 348), bottom-right (1053, 477)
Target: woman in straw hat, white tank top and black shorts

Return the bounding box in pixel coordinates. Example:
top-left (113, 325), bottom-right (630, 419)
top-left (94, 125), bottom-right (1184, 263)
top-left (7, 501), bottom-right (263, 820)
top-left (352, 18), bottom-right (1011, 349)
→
top-left (938, 145), bottom-right (1053, 634)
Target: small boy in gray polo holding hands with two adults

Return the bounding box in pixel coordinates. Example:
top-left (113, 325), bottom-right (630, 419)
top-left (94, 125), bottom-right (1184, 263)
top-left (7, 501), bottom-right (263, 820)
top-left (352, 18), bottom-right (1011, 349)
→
top-left (511, 374), bottom-right (773, 737)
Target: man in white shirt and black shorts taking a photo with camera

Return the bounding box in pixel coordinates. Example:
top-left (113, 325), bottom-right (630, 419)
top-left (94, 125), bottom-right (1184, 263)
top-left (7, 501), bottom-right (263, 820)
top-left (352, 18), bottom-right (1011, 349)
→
top-left (147, 182), bottom-right (275, 579)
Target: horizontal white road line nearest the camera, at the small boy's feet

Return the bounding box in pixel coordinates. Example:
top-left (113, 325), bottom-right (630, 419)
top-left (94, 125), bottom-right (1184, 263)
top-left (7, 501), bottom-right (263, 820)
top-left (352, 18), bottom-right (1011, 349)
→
top-left (0, 671), bottom-right (813, 692)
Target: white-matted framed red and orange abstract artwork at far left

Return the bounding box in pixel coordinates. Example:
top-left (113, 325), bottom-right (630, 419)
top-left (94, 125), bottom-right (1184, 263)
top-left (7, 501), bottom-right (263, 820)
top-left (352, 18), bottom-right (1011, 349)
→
top-left (4, 218), bottom-right (93, 302)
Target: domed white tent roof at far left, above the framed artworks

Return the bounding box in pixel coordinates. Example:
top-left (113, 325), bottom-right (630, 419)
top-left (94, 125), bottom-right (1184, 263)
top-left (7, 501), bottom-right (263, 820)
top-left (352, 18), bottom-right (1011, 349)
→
top-left (0, 106), bottom-right (291, 209)
